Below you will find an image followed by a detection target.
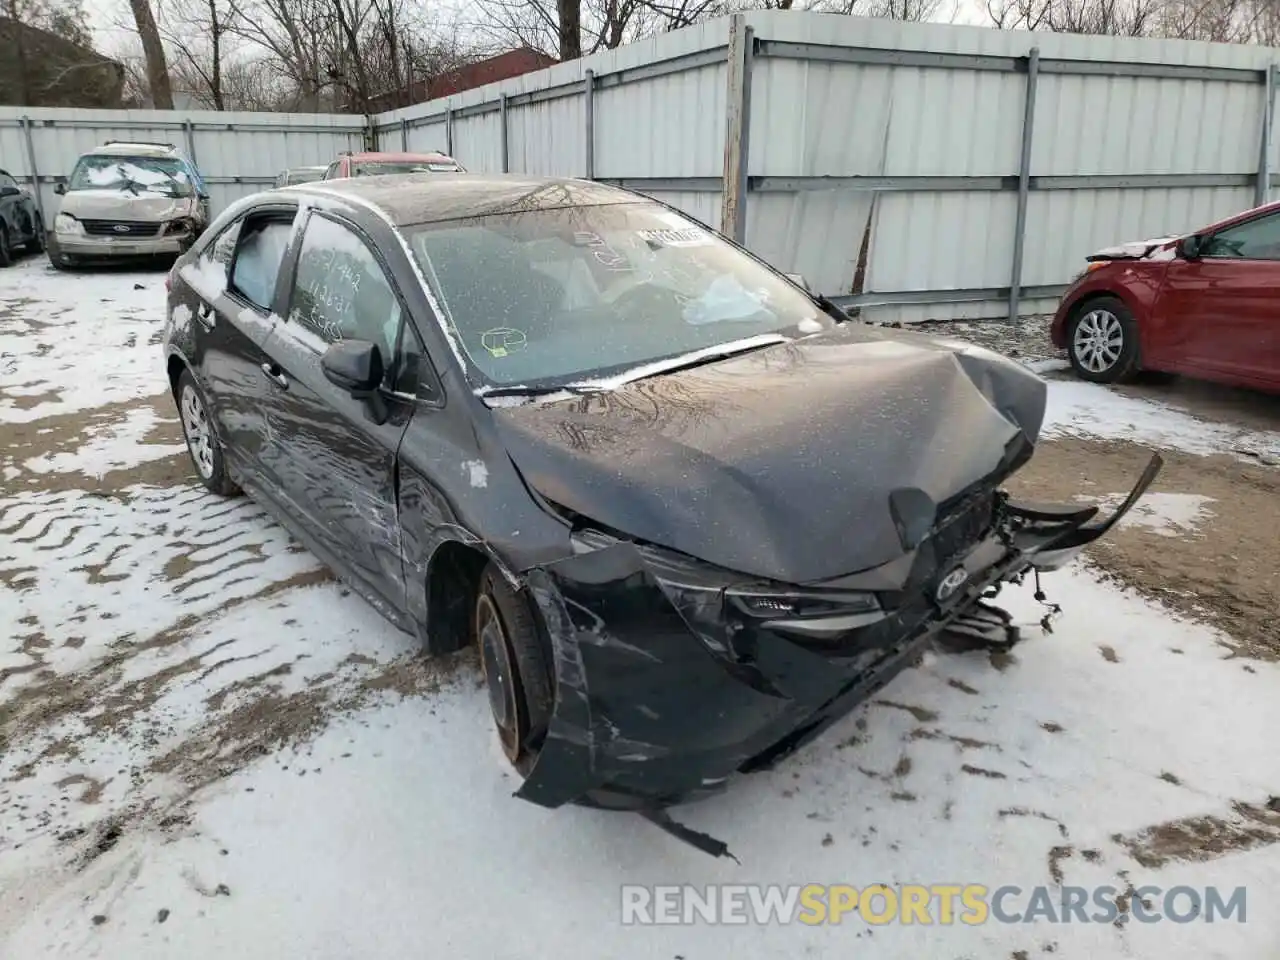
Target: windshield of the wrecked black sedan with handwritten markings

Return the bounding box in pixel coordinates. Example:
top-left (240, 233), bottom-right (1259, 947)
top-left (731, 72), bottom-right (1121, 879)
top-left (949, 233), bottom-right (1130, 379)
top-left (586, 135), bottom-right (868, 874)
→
top-left (410, 202), bottom-right (835, 389)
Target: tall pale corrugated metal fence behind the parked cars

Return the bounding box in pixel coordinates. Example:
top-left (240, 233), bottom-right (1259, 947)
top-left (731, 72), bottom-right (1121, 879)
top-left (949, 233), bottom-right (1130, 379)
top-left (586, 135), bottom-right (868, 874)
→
top-left (0, 10), bottom-right (1280, 320)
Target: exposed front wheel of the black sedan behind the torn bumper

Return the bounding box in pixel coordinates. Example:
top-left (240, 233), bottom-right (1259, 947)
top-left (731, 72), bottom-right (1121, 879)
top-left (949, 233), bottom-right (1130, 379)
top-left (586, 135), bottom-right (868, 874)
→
top-left (471, 563), bottom-right (556, 777)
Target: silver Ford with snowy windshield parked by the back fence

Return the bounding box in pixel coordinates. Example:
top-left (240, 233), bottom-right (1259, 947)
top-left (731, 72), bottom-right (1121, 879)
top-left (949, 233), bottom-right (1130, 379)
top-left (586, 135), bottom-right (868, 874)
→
top-left (49, 141), bottom-right (209, 270)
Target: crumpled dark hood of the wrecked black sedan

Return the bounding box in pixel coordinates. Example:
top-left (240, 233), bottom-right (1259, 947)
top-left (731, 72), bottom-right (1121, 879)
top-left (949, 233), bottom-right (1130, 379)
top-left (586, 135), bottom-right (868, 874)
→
top-left (493, 324), bottom-right (1046, 582)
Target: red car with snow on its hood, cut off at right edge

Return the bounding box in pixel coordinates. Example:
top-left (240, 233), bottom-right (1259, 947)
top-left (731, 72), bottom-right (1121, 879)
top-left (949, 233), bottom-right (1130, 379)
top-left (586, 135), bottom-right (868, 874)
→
top-left (1051, 202), bottom-right (1280, 392)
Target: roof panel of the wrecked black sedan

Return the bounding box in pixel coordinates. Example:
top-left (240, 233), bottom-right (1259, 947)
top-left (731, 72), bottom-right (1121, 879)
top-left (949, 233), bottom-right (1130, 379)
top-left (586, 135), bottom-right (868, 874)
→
top-left (289, 173), bottom-right (644, 227)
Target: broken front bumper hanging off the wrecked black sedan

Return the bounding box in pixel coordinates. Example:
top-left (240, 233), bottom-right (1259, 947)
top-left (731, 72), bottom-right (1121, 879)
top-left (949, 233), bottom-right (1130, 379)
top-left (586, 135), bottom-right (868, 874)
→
top-left (517, 456), bottom-right (1162, 810)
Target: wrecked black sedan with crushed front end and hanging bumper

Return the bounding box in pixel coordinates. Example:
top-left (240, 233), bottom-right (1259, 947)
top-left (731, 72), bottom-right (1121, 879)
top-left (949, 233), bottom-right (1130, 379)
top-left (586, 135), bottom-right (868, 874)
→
top-left (165, 174), bottom-right (1160, 839)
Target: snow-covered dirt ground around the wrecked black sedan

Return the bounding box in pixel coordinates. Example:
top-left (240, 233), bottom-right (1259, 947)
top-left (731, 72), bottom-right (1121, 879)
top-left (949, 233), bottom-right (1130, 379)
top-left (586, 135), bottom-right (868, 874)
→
top-left (0, 260), bottom-right (1280, 960)
